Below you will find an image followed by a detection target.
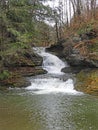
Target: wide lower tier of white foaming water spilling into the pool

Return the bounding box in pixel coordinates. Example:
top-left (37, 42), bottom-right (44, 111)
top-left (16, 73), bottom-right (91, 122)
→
top-left (26, 78), bottom-right (79, 94)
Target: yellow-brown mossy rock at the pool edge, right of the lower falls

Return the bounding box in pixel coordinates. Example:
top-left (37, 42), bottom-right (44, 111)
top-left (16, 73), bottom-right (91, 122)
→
top-left (76, 69), bottom-right (98, 95)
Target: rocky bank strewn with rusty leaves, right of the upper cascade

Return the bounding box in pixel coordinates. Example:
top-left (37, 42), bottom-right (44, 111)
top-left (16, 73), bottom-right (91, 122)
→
top-left (47, 29), bottom-right (98, 67)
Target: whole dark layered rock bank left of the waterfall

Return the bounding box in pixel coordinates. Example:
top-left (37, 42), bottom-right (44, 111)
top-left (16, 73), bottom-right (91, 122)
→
top-left (0, 49), bottom-right (46, 89)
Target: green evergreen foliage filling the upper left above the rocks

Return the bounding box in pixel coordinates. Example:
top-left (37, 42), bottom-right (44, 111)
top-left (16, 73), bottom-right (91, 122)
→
top-left (0, 0), bottom-right (51, 50)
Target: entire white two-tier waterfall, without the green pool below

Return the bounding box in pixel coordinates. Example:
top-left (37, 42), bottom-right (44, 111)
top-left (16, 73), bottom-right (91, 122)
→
top-left (26, 48), bottom-right (82, 94)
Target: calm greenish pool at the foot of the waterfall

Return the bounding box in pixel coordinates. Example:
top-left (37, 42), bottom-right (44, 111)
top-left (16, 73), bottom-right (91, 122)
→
top-left (0, 90), bottom-right (98, 130)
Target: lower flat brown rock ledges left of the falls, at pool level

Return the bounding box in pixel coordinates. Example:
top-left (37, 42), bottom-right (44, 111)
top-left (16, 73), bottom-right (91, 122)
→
top-left (0, 67), bottom-right (47, 89)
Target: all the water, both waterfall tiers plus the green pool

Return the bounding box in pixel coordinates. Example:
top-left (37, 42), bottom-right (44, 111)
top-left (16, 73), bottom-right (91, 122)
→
top-left (0, 48), bottom-right (98, 130)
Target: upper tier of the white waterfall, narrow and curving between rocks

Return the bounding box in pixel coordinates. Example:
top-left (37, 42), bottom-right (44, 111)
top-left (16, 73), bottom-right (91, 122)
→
top-left (35, 48), bottom-right (67, 74)
